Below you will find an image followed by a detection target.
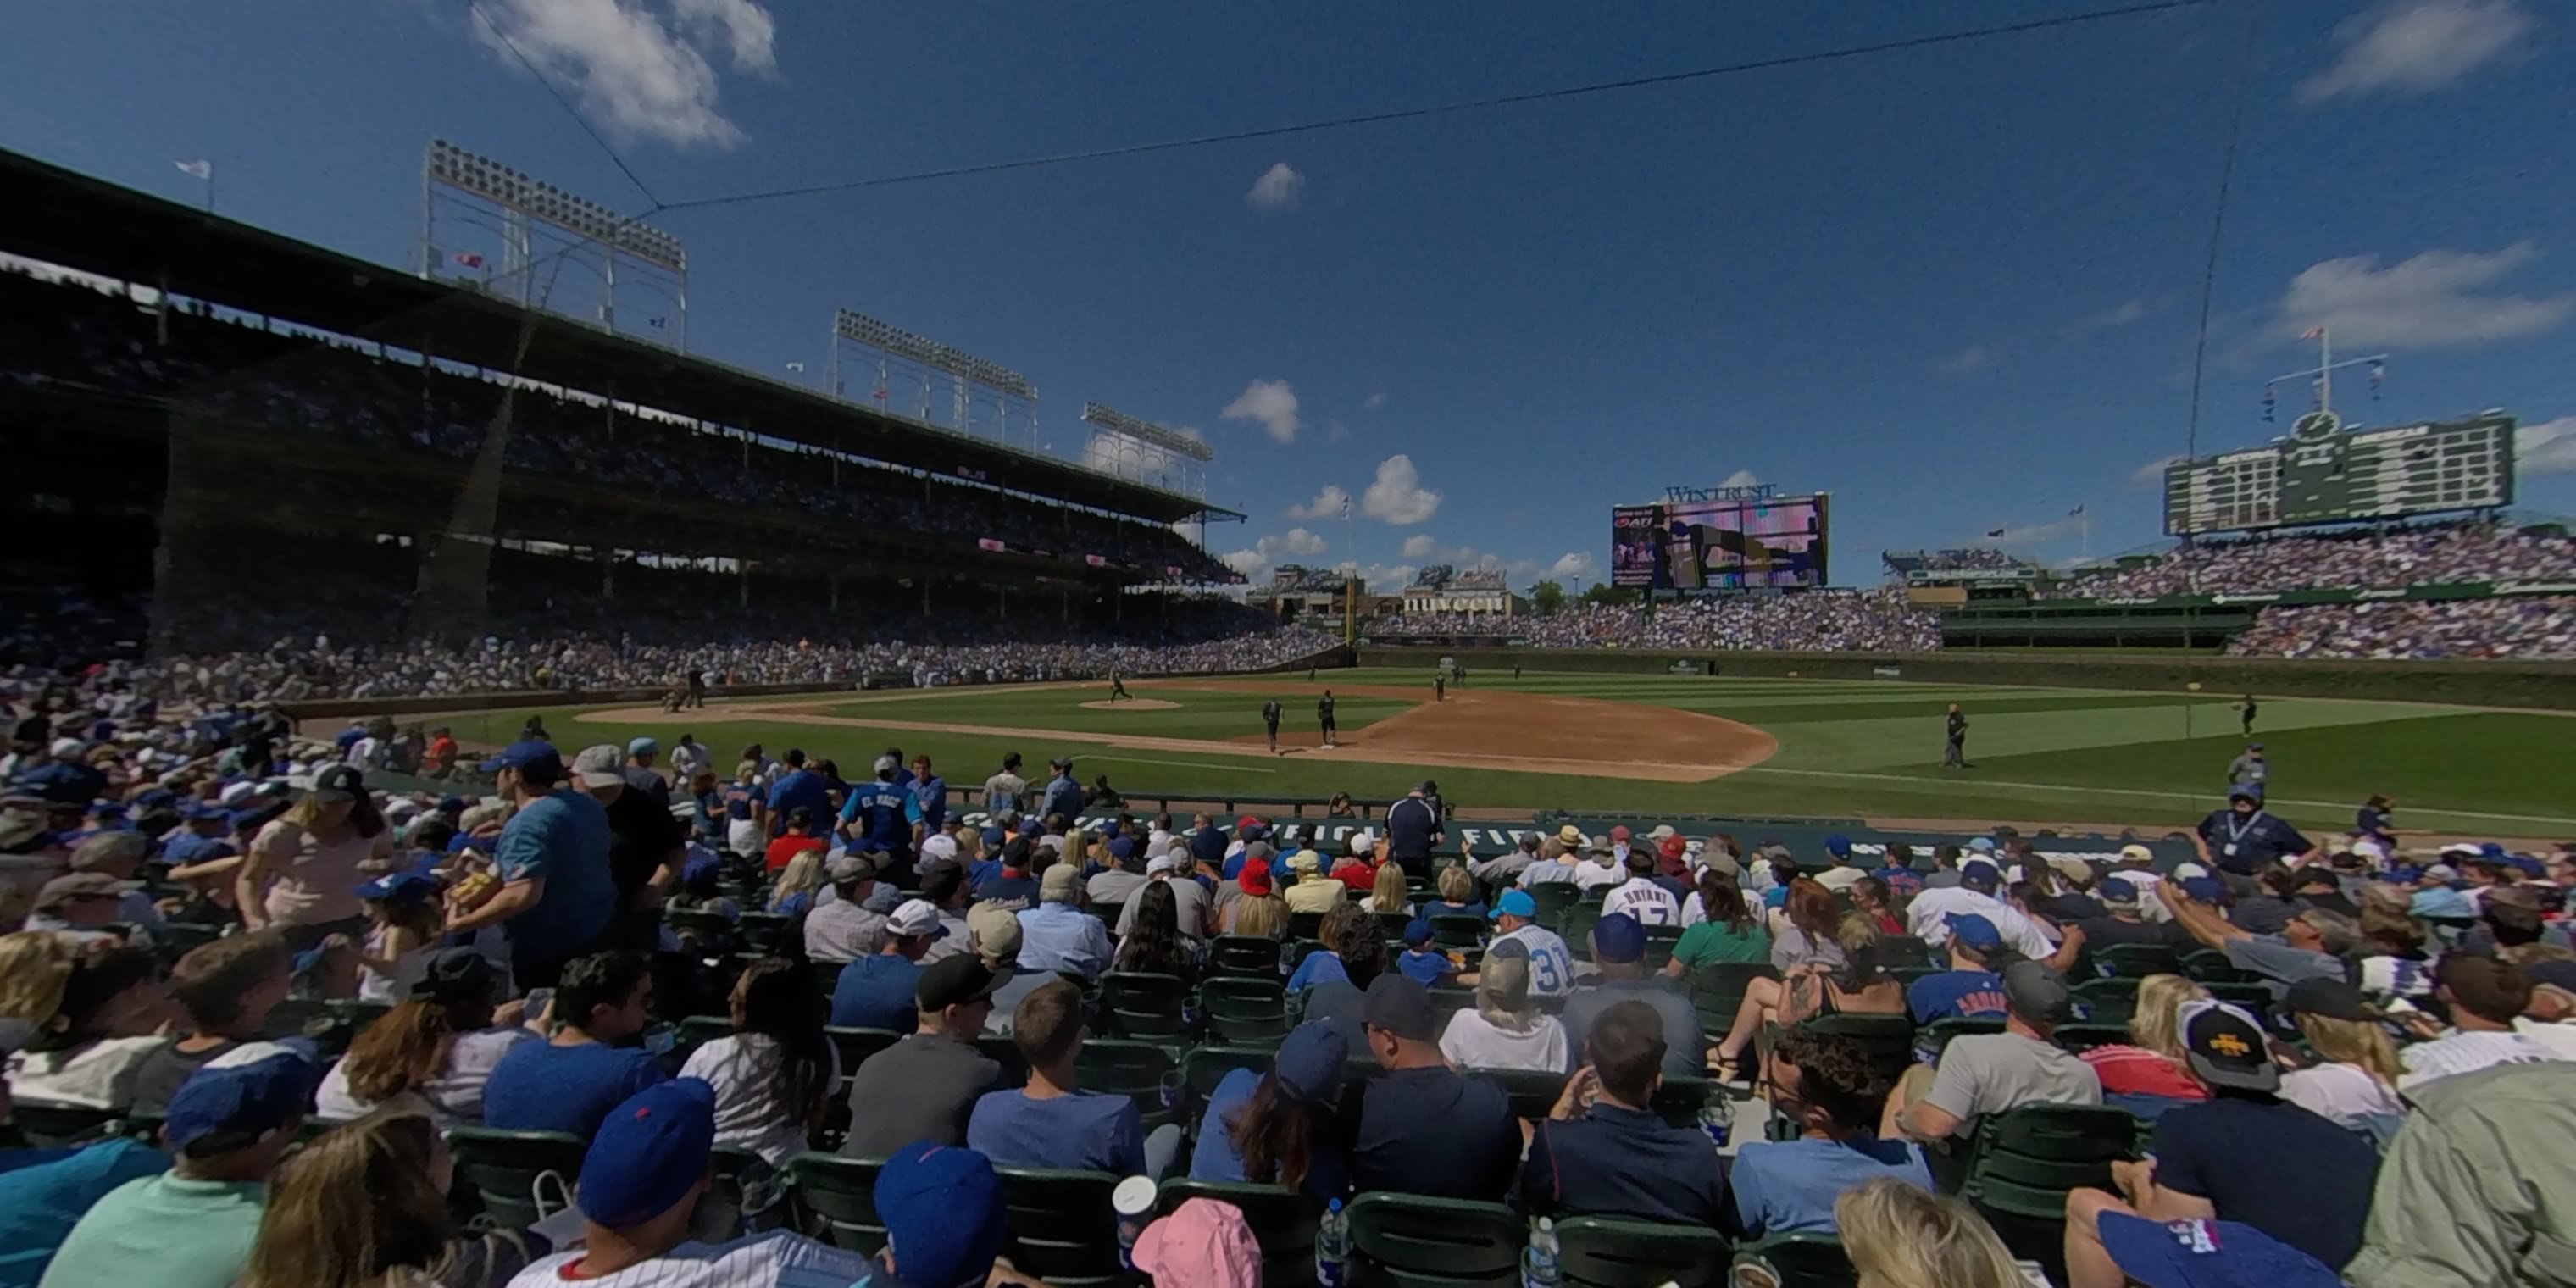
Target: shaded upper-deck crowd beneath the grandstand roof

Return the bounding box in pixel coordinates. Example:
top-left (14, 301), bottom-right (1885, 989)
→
top-left (0, 273), bottom-right (1241, 582)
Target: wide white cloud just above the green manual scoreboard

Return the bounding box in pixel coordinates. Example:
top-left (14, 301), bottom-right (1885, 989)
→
top-left (2272, 242), bottom-right (2576, 345)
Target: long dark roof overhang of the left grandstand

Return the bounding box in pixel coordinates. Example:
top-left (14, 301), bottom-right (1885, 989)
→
top-left (0, 149), bottom-right (1244, 523)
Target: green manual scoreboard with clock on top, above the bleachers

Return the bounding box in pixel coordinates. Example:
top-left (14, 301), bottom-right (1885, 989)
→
top-left (2164, 412), bottom-right (2514, 536)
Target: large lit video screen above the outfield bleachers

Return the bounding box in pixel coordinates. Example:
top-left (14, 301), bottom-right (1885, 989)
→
top-left (1610, 492), bottom-right (1826, 590)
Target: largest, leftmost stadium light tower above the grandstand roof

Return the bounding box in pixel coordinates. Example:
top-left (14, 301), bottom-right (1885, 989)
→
top-left (420, 139), bottom-right (688, 350)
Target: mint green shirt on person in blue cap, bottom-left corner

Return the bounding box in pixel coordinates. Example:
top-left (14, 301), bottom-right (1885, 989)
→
top-left (39, 1172), bottom-right (268, 1288)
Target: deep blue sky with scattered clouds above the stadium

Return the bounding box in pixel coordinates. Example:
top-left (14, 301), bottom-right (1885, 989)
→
top-left (0, 0), bottom-right (2576, 585)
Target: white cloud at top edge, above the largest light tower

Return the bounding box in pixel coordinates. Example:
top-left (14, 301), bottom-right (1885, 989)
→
top-left (474, 0), bottom-right (778, 147)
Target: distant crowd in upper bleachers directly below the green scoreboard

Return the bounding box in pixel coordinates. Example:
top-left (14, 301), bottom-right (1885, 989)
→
top-left (2043, 520), bottom-right (2576, 597)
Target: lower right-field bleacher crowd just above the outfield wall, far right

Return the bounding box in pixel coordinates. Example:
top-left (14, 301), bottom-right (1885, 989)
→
top-left (2229, 595), bottom-right (2576, 662)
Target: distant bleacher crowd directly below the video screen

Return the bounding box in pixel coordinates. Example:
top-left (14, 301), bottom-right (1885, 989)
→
top-left (1368, 592), bottom-right (1940, 652)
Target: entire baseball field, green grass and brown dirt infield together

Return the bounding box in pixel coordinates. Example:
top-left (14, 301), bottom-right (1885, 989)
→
top-left (422, 669), bottom-right (2576, 840)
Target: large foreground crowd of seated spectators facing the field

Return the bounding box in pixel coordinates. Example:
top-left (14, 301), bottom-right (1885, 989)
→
top-left (0, 672), bottom-right (2576, 1288)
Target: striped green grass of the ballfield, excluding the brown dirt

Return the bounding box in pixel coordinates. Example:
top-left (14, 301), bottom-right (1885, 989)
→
top-left (432, 669), bottom-right (2576, 837)
